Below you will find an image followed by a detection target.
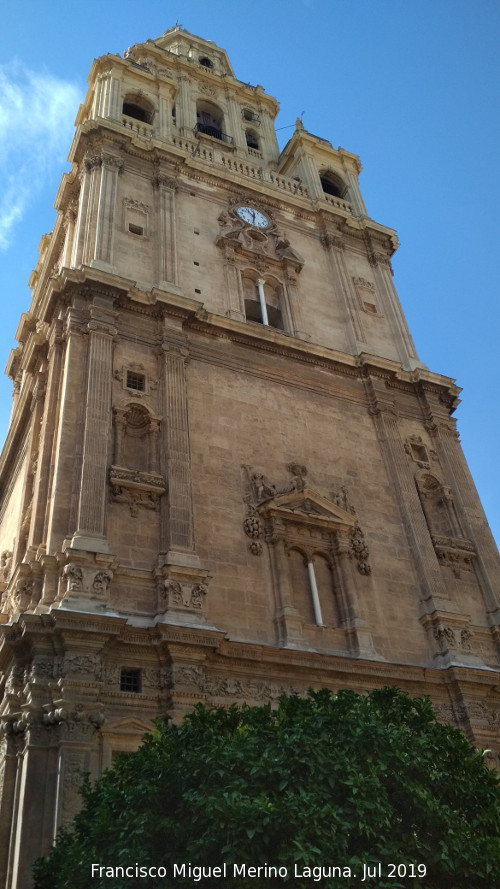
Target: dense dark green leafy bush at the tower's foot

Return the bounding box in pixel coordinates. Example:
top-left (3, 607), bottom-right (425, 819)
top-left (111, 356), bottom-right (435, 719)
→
top-left (35, 688), bottom-right (500, 889)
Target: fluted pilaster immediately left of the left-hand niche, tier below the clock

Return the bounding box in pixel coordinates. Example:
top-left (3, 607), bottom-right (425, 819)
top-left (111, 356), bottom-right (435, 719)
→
top-left (71, 297), bottom-right (117, 552)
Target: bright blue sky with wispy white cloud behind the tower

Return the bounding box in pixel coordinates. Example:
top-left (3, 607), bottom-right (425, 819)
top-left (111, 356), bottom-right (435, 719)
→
top-left (0, 0), bottom-right (500, 540)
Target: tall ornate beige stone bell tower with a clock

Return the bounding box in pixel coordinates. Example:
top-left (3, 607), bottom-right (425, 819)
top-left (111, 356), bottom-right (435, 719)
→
top-left (0, 28), bottom-right (500, 889)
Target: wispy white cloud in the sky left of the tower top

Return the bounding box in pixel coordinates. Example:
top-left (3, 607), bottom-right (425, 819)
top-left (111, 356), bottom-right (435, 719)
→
top-left (0, 62), bottom-right (81, 250)
